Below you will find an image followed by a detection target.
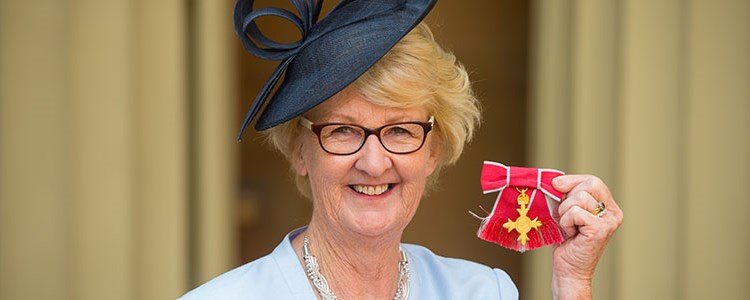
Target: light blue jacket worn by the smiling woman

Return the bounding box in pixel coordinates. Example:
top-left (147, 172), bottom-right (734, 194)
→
top-left (180, 227), bottom-right (518, 300)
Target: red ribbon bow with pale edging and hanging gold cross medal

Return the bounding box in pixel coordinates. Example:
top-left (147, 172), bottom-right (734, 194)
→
top-left (477, 161), bottom-right (564, 252)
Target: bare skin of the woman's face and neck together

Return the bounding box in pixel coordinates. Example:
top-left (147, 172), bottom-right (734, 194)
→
top-left (292, 88), bottom-right (439, 299)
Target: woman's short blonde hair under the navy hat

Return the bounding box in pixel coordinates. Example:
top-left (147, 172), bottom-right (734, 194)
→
top-left (264, 22), bottom-right (481, 198)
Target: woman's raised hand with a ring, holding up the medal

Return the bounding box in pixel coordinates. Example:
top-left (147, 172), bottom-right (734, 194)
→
top-left (552, 175), bottom-right (623, 299)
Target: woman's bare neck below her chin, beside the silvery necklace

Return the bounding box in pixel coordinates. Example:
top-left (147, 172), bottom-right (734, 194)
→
top-left (293, 216), bottom-right (408, 299)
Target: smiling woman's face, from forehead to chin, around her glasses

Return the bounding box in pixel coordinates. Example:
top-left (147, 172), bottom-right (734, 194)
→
top-left (293, 88), bottom-right (439, 237)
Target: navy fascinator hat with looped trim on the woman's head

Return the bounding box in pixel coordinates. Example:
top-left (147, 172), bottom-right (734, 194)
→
top-left (234, 0), bottom-right (436, 141)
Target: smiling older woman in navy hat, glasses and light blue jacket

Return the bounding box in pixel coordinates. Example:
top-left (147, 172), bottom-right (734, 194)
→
top-left (183, 0), bottom-right (622, 299)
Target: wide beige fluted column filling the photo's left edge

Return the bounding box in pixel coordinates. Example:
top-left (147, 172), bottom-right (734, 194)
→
top-left (0, 0), bottom-right (195, 300)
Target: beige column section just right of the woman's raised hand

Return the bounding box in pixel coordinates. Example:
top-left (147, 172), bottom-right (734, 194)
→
top-left (616, 1), bottom-right (686, 299)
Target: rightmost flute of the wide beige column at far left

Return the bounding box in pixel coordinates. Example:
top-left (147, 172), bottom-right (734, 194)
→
top-left (130, 0), bottom-right (191, 299)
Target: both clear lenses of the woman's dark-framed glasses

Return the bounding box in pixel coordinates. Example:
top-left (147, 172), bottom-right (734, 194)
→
top-left (320, 123), bottom-right (425, 154)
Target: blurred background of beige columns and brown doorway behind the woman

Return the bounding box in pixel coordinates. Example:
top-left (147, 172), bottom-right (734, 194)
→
top-left (0, 0), bottom-right (750, 300)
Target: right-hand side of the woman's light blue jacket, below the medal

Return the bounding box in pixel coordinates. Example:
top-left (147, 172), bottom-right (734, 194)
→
top-left (402, 244), bottom-right (518, 300)
